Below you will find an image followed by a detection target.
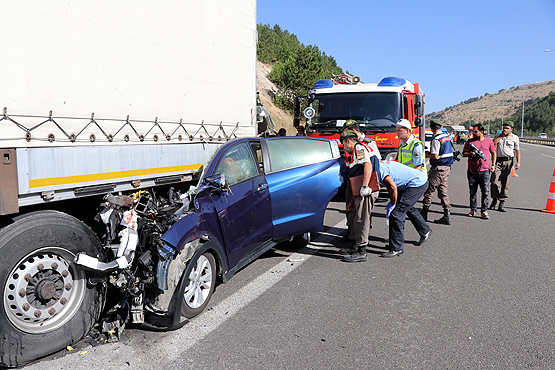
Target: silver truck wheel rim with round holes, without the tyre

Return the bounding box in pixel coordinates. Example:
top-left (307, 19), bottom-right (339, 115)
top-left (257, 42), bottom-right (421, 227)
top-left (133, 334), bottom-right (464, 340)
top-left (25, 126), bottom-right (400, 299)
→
top-left (3, 247), bottom-right (86, 334)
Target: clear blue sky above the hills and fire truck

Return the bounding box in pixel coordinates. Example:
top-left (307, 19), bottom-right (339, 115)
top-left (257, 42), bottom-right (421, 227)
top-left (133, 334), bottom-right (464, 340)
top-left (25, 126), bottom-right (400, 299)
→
top-left (257, 0), bottom-right (555, 113)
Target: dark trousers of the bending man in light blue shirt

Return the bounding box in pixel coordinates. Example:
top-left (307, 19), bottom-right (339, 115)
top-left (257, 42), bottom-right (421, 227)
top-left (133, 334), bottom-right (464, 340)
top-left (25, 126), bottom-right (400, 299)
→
top-left (389, 181), bottom-right (431, 251)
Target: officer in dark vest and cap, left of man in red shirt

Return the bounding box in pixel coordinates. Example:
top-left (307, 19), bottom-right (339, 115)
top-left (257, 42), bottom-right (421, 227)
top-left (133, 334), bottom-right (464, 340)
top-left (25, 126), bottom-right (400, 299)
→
top-left (420, 119), bottom-right (453, 225)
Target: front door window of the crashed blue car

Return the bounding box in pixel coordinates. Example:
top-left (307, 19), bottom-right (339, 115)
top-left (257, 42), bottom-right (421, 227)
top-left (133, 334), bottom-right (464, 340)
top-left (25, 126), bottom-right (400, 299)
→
top-left (214, 143), bottom-right (258, 185)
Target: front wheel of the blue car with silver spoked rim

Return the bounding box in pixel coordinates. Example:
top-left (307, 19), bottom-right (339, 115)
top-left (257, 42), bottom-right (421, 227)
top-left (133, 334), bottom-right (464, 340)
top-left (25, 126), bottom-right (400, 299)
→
top-left (181, 252), bottom-right (216, 318)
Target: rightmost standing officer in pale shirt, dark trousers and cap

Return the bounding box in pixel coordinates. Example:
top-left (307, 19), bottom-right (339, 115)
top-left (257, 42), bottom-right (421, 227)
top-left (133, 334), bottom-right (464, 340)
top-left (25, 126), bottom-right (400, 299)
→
top-left (490, 121), bottom-right (520, 212)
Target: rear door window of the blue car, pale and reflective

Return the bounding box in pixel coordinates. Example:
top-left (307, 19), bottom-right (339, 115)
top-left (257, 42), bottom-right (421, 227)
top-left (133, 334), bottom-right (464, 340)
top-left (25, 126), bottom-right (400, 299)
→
top-left (268, 138), bottom-right (333, 172)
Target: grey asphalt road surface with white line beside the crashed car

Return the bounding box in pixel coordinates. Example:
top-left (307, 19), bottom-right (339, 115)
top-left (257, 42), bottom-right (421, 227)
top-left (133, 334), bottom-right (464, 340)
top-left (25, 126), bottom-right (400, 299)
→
top-left (24, 144), bottom-right (555, 370)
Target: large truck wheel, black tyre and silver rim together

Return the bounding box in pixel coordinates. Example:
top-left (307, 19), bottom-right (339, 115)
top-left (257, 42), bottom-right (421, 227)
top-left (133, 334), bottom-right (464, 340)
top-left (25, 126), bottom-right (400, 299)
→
top-left (0, 211), bottom-right (105, 367)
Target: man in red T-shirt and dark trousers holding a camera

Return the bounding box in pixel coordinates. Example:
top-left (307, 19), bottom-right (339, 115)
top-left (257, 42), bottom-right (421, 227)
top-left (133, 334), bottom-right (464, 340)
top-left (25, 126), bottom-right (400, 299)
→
top-left (462, 123), bottom-right (497, 220)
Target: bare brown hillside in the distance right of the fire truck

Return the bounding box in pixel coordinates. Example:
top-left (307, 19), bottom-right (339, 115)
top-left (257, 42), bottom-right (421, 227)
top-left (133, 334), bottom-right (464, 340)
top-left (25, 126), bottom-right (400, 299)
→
top-left (426, 80), bottom-right (555, 126)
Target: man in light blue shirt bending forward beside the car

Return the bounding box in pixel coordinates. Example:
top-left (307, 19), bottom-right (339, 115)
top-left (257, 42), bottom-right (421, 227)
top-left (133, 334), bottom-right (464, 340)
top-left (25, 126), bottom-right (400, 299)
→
top-left (378, 161), bottom-right (432, 258)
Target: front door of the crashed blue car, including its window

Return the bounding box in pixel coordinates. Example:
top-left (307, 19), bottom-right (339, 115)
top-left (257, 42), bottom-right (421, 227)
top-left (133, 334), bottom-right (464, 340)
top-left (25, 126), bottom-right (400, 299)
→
top-left (211, 140), bottom-right (272, 268)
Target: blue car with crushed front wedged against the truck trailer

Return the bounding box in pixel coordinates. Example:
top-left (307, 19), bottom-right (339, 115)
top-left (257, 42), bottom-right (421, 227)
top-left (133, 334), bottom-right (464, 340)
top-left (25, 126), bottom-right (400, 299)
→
top-left (158, 137), bottom-right (341, 322)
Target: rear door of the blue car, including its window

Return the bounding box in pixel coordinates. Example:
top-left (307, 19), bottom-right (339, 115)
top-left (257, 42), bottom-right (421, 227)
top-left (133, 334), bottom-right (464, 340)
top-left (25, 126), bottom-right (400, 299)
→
top-left (265, 136), bottom-right (342, 240)
